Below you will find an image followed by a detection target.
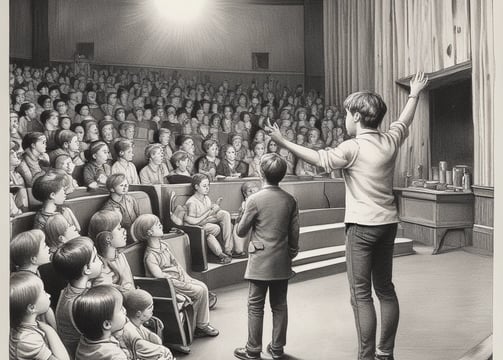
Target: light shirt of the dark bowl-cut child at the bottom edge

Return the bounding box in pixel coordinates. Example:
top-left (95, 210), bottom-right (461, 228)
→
top-left (75, 336), bottom-right (128, 360)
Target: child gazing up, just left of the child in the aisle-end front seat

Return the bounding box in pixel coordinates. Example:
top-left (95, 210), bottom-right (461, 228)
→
top-left (88, 210), bottom-right (134, 292)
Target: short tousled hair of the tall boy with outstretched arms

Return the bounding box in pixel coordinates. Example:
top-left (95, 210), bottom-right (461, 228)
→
top-left (344, 91), bottom-right (388, 129)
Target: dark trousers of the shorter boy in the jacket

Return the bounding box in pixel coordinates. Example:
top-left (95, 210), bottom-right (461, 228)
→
top-left (246, 280), bottom-right (288, 353)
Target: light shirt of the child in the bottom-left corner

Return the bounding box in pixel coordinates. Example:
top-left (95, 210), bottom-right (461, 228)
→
top-left (9, 323), bottom-right (52, 360)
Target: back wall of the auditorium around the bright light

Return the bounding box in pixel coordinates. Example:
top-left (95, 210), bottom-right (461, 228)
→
top-left (49, 0), bottom-right (304, 73)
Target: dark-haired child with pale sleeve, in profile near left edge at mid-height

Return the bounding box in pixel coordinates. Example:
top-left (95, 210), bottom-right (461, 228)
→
top-left (32, 171), bottom-right (80, 231)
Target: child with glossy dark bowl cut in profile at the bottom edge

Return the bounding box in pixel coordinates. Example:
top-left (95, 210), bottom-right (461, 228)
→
top-left (73, 285), bottom-right (127, 360)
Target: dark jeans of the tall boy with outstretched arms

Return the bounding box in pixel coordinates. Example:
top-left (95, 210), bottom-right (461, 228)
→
top-left (346, 224), bottom-right (399, 360)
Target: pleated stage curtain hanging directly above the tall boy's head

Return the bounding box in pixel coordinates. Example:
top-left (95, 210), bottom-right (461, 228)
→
top-left (324, 0), bottom-right (374, 106)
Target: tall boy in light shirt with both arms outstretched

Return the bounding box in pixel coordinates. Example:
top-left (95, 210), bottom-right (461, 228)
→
top-left (267, 72), bottom-right (428, 360)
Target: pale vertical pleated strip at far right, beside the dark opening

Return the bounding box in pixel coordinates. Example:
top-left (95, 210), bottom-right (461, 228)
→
top-left (470, 0), bottom-right (495, 186)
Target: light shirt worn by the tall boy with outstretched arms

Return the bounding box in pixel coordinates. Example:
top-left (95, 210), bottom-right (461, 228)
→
top-left (318, 121), bottom-right (408, 225)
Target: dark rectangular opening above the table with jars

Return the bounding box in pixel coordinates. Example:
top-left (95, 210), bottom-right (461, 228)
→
top-left (430, 79), bottom-right (473, 171)
